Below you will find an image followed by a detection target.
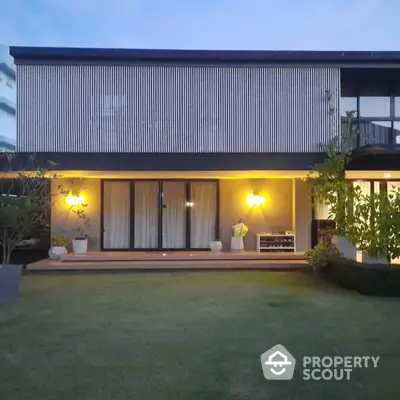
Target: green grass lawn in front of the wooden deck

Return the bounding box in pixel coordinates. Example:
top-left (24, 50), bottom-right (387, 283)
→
top-left (0, 271), bottom-right (400, 400)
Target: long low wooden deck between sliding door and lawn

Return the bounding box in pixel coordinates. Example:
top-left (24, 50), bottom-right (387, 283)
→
top-left (27, 251), bottom-right (307, 271)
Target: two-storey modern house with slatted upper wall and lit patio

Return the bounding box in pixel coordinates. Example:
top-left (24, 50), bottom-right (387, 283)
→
top-left (7, 47), bottom-right (400, 251)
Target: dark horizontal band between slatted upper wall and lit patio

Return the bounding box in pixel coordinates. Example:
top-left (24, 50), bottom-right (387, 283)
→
top-left (0, 152), bottom-right (325, 172)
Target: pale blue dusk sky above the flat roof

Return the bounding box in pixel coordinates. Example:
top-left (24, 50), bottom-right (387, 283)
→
top-left (0, 0), bottom-right (400, 50)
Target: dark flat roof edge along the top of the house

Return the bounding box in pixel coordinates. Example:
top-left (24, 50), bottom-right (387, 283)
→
top-left (10, 47), bottom-right (400, 66)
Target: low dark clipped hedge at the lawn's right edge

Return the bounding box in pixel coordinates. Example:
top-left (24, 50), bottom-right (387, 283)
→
top-left (322, 259), bottom-right (400, 297)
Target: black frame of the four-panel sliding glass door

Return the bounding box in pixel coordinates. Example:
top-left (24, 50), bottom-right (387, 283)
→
top-left (100, 178), bottom-right (220, 252)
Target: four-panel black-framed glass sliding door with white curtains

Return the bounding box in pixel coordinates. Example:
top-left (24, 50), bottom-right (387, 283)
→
top-left (102, 180), bottom-right (218, 250)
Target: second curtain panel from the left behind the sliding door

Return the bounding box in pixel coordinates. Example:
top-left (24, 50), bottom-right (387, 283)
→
top-left (135, 181), bottom-right (158, 249)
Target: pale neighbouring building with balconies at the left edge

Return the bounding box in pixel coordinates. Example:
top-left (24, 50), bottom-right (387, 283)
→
top-left (0, 45), bottom-right (17, 152)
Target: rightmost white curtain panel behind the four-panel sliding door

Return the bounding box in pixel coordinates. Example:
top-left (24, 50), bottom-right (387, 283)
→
top-left (190, 182), bottom-right (217, 248)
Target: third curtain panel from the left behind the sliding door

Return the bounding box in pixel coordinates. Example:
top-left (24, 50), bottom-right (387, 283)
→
top-left (163, 182), bottom-right (186, 249)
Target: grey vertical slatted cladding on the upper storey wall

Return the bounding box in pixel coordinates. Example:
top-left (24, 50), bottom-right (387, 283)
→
top-left (17, 65), bottom-right (340, 153)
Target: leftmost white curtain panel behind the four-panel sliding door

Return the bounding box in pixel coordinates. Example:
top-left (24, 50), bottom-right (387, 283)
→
top-left (103, 181), bottom-right (130, 249)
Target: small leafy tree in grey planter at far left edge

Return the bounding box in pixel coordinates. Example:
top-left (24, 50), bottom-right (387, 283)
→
top-left (0, 153), bottom-right (57, 301)
